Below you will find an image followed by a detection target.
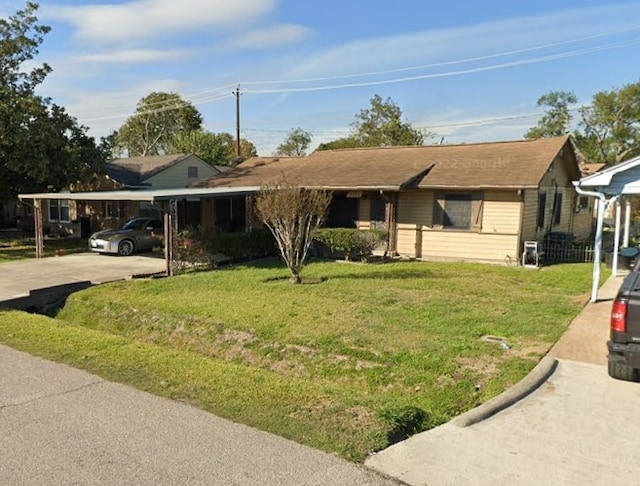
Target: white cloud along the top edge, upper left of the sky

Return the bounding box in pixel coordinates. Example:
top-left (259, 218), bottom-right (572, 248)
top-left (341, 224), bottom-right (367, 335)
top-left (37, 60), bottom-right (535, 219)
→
top-left (42, 0), bottom-right (276, 43)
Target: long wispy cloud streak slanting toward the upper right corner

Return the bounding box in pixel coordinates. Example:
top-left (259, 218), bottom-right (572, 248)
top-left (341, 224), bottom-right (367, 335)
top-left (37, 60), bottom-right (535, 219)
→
top-left (292, 2), bottom-right (640, 76)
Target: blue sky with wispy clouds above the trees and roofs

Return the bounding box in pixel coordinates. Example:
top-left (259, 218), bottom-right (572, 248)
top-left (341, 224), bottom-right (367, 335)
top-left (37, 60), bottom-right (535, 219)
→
top-left (5, 0), bottom-right (640, 156)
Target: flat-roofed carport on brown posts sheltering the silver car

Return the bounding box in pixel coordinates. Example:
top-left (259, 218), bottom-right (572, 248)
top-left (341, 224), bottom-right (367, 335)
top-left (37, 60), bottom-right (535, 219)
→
top-left (18, 186), bottom-right (260, 275)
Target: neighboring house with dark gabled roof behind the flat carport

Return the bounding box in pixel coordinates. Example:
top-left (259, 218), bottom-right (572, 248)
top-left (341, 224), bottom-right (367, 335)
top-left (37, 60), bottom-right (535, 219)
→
top-left (34, 154), bottom-right (222, 236)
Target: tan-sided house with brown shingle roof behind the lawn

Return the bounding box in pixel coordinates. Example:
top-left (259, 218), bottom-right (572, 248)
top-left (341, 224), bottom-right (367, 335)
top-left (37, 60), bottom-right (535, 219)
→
top-left (193, 137), bottom-right (592, 262)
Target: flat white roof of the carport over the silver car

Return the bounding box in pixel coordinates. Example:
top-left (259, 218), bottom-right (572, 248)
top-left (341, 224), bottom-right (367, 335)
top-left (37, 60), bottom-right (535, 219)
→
top-left (18, 186), bottom-right (260, 202)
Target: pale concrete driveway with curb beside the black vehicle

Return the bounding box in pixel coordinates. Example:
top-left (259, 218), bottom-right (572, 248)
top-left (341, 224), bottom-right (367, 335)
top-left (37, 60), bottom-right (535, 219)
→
top-left (366, 278), bottom-right (640, 486)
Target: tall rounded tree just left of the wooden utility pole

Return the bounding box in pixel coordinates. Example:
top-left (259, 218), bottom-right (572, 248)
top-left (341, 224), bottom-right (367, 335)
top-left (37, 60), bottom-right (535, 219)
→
top-left (116, 92), bottom-right (202, 157)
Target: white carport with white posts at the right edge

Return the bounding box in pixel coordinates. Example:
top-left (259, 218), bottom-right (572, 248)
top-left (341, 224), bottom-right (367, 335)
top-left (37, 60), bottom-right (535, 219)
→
top-left (573, 157), bottom-right (640, 302)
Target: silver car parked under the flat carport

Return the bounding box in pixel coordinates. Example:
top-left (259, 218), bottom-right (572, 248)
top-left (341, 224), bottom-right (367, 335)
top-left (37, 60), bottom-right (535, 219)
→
top-left (89, 218), bottom-right (164, 256)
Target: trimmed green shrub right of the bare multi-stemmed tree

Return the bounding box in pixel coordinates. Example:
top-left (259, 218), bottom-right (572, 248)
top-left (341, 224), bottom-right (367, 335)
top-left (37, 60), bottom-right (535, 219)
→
top-left (313, 228), bottom-right (387, 260)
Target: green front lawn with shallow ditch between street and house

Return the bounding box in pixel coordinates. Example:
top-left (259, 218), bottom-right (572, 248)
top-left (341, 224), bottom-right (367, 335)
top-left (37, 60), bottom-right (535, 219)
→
top-left (0, 260), bottom-right (604, 461)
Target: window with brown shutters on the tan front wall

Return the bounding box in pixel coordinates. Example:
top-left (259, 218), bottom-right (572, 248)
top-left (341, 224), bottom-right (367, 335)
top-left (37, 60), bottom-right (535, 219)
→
top-left (433, 192), bottom-right (484, 231)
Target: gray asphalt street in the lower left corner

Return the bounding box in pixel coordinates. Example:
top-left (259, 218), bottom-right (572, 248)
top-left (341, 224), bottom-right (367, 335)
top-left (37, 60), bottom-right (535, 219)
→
top-left (0, 345), bottom-right (399, 486)
